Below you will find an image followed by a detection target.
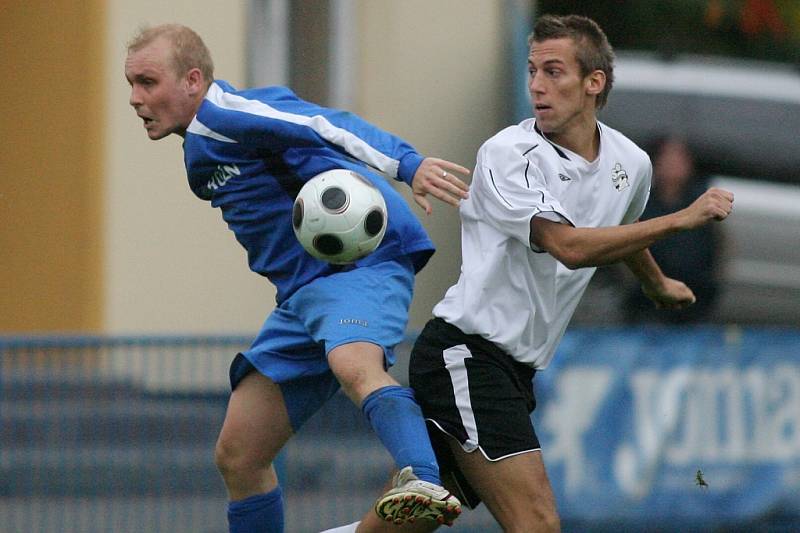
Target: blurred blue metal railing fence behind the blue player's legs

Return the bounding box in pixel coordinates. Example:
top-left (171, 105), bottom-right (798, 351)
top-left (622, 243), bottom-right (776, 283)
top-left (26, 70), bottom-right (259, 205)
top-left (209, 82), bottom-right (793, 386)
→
top-left (0, 336), bottom-right (496, 533)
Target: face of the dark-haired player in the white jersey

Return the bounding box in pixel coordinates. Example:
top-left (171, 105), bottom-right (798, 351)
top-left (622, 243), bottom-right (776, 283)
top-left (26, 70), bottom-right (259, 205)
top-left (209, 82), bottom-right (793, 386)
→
top-left (528, 38), bottom-right (595, 140)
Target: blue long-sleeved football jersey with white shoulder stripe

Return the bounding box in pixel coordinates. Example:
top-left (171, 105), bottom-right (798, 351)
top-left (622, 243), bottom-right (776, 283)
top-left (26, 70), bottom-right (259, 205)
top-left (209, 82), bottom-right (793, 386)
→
top-left (183, 80), bottom-right (434, 303)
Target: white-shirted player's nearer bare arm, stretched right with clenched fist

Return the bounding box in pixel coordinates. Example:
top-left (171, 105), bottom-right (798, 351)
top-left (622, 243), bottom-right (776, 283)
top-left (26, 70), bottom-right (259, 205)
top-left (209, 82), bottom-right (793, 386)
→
top-left (530, 188), bottom-right (733, 269)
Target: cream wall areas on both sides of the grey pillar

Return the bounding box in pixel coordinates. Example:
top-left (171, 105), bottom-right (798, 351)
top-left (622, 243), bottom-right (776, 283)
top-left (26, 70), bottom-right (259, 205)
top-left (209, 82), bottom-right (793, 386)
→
top-left (104, 0), bottom-right (510, 334)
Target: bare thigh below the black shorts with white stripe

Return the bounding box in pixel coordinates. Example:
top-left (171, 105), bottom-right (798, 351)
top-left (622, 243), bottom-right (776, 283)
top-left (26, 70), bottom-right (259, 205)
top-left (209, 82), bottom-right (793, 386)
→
top-left (450, 440), bottom-right (559, 532)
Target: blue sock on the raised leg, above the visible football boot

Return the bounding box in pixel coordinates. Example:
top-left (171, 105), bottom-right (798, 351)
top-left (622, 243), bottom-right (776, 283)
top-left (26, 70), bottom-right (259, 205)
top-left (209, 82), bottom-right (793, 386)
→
top-left (361, 385), bottom-right (442, 485)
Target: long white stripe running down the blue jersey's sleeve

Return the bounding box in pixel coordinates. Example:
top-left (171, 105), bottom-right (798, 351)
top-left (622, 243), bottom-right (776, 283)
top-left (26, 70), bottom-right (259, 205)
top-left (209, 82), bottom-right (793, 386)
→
top-left (206, 83), bottom-right (400, 178)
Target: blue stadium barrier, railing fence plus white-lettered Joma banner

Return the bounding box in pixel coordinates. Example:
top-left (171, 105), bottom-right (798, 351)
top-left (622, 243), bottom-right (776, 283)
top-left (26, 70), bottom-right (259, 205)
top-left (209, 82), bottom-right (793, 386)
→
top-left (0, 327), bottom-right (800, 533)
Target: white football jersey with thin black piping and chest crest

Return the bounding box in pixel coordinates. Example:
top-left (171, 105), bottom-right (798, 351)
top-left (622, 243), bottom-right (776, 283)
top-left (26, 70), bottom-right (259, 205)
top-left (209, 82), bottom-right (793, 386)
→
top-left (433, 118), bottom-right (652, 368)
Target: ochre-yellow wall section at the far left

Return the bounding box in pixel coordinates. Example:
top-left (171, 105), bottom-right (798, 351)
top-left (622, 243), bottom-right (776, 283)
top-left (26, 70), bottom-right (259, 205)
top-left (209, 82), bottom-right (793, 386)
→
top-left (0, 0), bottom-right (105, 332)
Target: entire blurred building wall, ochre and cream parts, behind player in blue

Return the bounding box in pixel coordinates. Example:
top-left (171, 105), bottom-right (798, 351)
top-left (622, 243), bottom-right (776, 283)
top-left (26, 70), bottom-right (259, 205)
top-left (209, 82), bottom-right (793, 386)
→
top-left (0, 0), bottom-right (512, 333)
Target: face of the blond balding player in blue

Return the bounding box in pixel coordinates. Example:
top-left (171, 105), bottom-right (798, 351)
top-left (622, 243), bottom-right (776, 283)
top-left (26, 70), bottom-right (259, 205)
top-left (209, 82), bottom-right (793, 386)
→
top-left (125, 38), bottom-right (197, 140)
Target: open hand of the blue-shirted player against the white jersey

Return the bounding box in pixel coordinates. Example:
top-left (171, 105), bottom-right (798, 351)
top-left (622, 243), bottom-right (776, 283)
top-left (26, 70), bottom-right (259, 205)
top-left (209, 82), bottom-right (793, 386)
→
top-left (411, 157), bottom-right (470, 215)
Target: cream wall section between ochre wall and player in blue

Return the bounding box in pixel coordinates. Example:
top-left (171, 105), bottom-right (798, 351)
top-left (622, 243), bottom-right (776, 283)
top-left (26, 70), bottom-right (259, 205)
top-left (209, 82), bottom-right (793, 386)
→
top-left (104, 0), bottom-right (274, 334)
